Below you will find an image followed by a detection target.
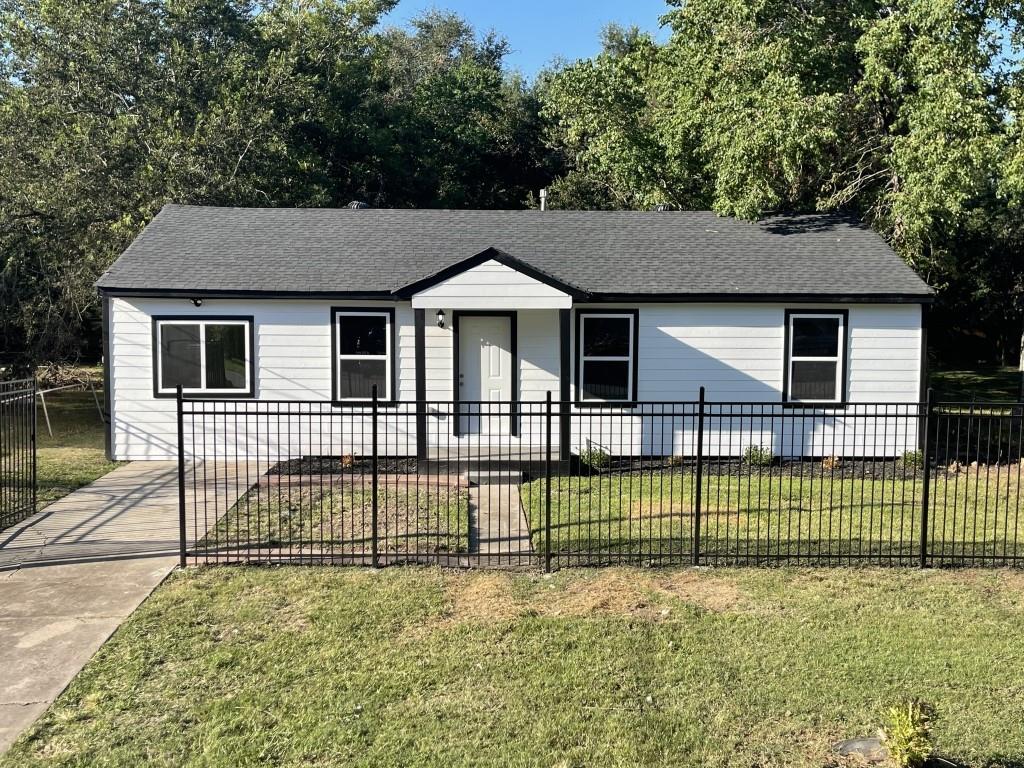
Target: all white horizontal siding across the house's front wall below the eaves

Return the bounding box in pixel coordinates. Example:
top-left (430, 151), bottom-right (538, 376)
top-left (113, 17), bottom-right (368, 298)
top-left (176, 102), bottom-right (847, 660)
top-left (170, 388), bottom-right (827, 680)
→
top-left (111, 299), bottom-right (921, 459)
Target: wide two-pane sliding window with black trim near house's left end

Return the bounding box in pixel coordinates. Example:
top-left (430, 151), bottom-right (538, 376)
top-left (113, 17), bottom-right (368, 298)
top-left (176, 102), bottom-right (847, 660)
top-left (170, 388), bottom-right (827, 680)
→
top-left (154, 317), bottom-right (253, 396)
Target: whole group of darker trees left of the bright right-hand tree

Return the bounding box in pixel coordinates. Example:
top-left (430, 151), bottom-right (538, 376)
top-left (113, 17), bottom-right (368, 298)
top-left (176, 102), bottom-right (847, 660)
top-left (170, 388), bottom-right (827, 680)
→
top-left (0, 0), bottom-right (547, 369)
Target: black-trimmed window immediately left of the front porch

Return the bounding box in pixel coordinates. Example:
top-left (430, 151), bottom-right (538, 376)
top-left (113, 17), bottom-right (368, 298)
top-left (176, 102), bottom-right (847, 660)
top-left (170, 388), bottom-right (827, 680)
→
top-left (334, 309), bottom-right (394, 400)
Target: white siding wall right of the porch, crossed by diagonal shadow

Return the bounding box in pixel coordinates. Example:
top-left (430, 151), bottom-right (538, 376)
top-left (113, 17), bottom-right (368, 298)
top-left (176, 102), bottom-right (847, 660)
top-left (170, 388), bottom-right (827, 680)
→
top-left (571, 304), bottom-right (922, 456)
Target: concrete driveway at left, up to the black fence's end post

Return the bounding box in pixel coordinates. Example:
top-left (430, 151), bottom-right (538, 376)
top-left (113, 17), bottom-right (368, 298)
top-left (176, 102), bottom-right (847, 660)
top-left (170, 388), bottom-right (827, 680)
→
top-left (0, 462), bottom-right (212, 752)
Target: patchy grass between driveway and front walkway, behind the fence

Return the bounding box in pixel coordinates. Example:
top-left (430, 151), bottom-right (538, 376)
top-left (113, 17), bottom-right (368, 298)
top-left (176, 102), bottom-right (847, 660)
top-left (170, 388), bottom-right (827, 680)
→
top-left (198, 483), bottom-right (469, 555)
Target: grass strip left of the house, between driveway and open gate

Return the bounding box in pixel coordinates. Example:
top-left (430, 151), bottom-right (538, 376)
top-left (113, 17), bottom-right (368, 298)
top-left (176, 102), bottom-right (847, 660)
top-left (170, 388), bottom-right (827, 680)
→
top-left (36, 391), bottom-right (120, 508)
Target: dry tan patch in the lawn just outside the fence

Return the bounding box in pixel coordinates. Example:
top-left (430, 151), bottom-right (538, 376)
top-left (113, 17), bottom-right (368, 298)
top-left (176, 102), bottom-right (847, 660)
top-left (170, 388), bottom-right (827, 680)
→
top-left (442, 568), bottom-right (746, 625)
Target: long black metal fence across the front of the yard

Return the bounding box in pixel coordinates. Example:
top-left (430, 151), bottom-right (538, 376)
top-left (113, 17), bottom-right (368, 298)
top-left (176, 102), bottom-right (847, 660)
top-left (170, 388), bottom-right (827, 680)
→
top-left (178, 396), bottom-right (1024, 568)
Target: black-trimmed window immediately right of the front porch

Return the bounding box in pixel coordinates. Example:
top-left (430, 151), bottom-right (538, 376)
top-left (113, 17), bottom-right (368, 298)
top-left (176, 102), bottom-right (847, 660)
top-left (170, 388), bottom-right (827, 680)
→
top-left (577, 311), bottom-right (637, 402)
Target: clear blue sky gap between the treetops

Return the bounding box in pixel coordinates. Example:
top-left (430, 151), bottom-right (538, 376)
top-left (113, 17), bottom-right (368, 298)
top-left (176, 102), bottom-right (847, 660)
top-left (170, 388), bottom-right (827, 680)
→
top-left (385, 0), bottom-right (668, 77)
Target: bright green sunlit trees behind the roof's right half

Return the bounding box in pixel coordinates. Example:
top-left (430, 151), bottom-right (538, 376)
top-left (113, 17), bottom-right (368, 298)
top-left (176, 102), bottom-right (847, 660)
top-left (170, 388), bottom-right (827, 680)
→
top-left (544, 0), bottom-right (1024, 358)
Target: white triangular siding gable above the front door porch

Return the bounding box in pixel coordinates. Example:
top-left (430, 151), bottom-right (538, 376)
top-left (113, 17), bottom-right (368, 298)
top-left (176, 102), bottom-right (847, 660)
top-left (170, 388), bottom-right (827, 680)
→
top-left (413, 259), bottom-right (572, 309)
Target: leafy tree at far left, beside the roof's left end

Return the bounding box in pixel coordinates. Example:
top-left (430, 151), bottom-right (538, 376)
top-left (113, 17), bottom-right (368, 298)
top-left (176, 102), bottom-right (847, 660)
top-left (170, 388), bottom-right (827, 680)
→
top-left (0, 0), bottom-right (390, 366)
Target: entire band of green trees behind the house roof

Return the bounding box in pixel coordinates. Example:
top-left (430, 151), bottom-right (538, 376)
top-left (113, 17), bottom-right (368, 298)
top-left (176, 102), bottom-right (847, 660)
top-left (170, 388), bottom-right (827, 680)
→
top-left (0, 0), bottom-right (1024, 367)
